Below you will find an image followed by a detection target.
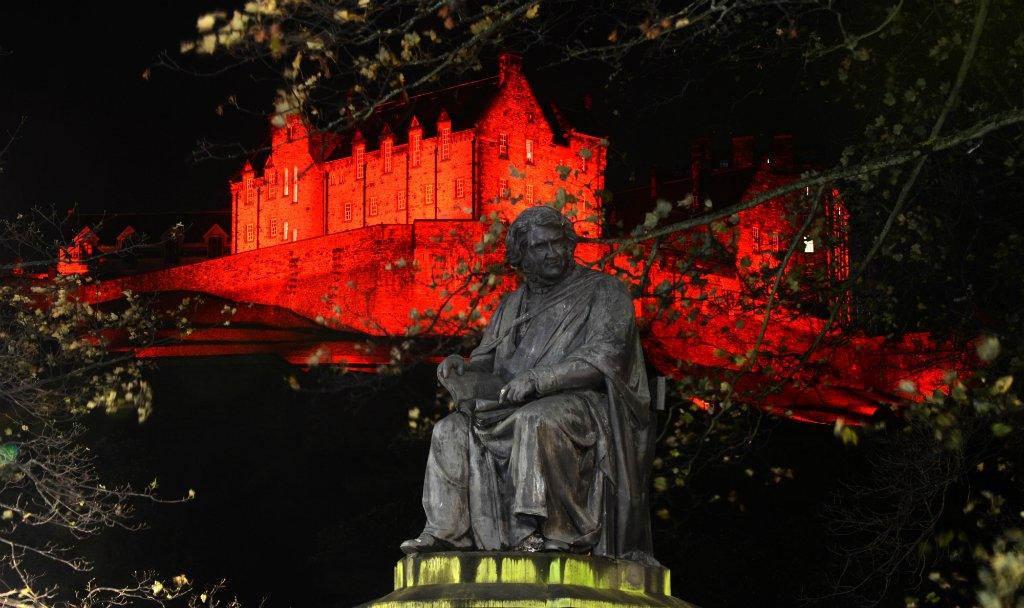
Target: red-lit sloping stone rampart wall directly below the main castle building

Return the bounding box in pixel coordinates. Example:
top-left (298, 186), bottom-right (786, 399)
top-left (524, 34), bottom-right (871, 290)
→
top-left (87, 220), bottom-right (500, 336)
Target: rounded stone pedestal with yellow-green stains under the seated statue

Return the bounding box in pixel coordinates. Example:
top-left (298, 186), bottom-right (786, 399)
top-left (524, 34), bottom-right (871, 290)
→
top-left (364, 552), bottom-right (695, 608)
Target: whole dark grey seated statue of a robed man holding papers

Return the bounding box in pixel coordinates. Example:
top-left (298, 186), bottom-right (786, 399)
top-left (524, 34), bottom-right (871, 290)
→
top-left (401, 207), bottom-right (656, 564)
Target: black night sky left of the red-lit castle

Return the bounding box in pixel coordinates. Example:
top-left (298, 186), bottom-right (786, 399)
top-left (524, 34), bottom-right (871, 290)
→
top-left (0, 0), bottom-right (264, 215)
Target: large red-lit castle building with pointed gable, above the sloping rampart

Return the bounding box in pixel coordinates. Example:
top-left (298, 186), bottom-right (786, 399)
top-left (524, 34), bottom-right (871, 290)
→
top-left (231, 50), bottom-right (605, 253)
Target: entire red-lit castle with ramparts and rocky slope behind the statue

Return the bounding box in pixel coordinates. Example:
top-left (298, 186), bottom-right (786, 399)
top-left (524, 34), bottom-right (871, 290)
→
top-left (74, 54), bottom-right (949, 420)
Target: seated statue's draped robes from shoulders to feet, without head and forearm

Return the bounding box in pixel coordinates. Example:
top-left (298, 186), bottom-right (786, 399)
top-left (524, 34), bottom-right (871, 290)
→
top-left (423, 266), bottom-right (654, 562)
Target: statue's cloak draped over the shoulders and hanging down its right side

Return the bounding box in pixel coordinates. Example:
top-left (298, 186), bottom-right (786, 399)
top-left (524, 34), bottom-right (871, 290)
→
top-left (460, 266), bottom-right (654, 561)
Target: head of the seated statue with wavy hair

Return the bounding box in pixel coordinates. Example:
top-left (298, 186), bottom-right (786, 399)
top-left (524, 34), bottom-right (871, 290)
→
top-left (505, 206), bottom-right (580, 283)
